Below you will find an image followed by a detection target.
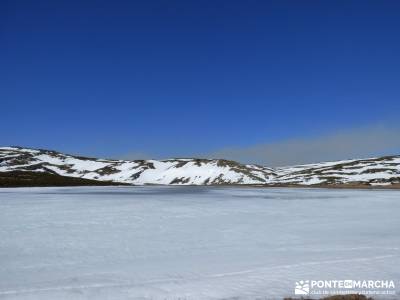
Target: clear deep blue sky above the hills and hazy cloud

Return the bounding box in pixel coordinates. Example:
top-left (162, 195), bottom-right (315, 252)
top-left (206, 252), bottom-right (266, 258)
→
top-left (0, 0), bottom-right (400, 162)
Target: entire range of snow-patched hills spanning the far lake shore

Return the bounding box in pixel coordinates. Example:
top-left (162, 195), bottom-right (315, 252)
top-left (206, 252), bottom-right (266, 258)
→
top-left (0, 147), bottom-right (400, 186)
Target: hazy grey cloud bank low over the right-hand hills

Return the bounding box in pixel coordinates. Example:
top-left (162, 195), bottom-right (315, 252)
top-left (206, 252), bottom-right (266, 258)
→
top-left (206, 125), bottom-right (400, 167)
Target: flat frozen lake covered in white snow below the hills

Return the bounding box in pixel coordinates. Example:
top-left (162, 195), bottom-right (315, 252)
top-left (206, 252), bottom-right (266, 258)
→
top-left (0, 187), bottom-right (400, 299)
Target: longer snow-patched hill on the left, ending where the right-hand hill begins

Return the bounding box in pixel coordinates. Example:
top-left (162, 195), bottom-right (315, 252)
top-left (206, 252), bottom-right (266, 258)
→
top-left (0, 147), bottom-right (275, 185)
